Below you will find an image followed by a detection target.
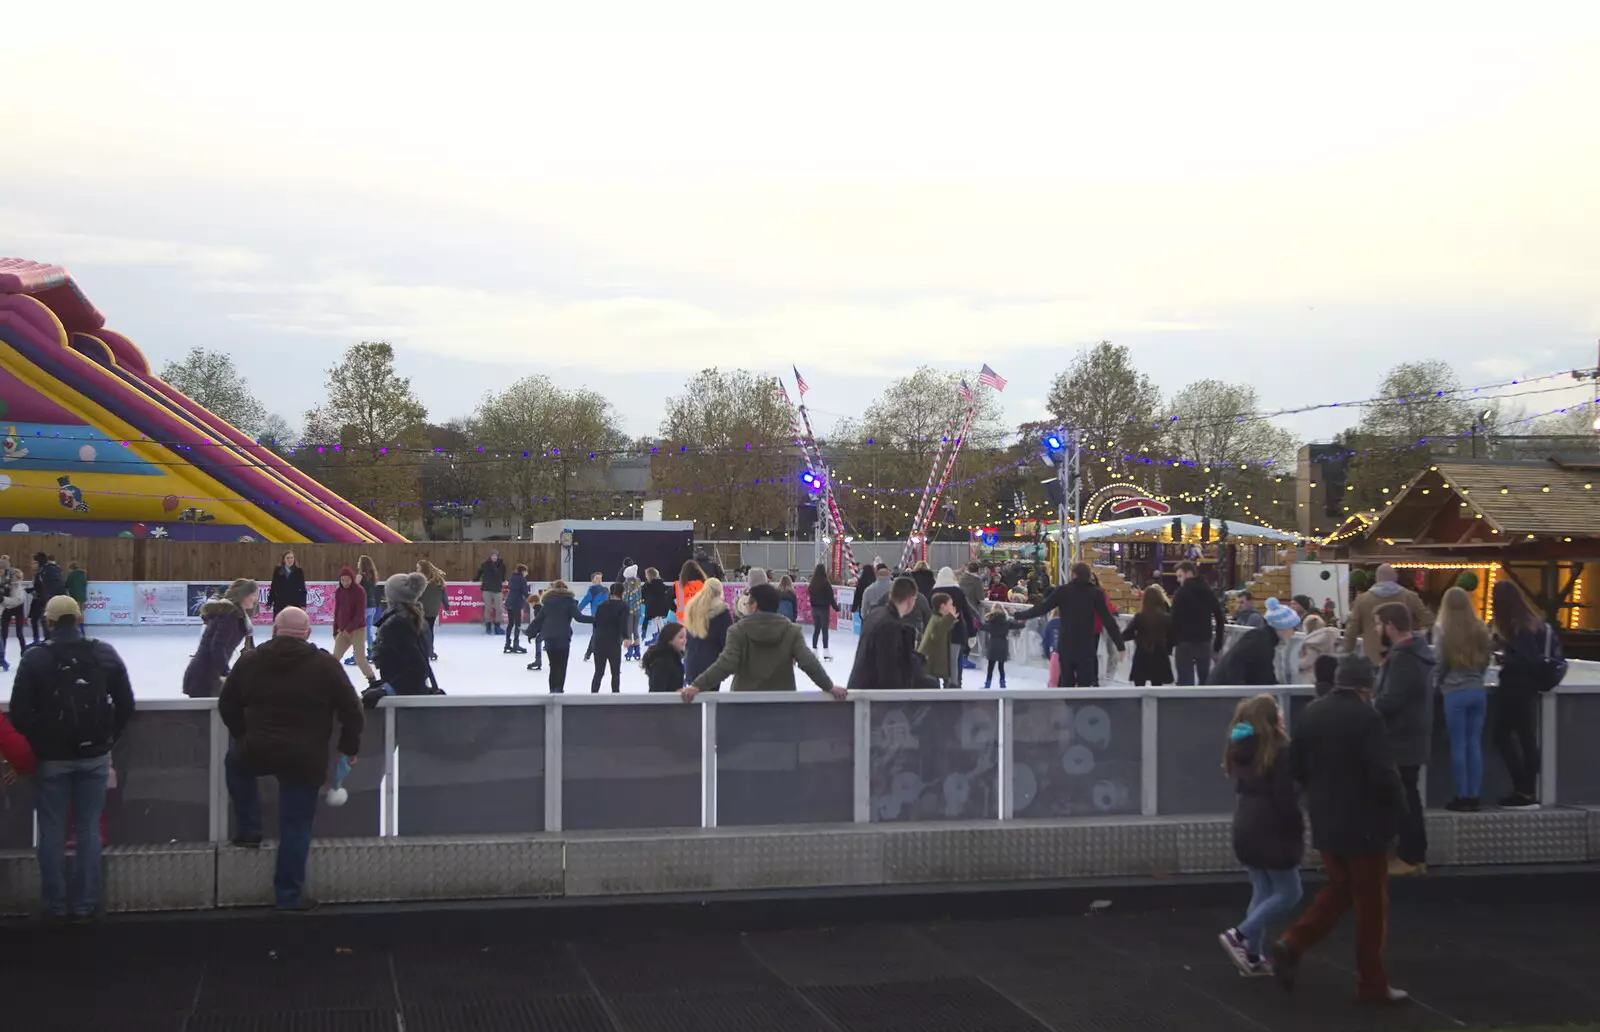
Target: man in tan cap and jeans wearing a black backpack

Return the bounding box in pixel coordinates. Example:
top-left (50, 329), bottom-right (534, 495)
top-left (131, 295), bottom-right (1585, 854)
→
top-left (11, 595), bottom-right (133, 922)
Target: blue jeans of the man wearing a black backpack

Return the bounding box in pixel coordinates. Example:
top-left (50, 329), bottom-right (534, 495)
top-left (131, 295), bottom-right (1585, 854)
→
top-left (34, 754), bottom-right (110, 917)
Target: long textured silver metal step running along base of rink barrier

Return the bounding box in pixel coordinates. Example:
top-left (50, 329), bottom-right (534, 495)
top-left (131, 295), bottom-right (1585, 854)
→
top-left (0, 808), bottom-right (1600, 917)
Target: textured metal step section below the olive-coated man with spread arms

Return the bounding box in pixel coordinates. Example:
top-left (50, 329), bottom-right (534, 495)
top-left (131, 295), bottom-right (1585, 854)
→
top-left (566, 826), bottom-right (883, 896)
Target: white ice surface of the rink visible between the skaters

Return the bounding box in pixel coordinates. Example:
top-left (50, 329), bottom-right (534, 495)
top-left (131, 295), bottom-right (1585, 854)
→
top-left (0, 626), bottom-right (1081, 699)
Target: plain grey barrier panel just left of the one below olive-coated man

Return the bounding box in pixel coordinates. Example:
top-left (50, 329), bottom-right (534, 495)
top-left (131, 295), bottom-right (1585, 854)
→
top-left (562, 706), bottom-right (702, 830)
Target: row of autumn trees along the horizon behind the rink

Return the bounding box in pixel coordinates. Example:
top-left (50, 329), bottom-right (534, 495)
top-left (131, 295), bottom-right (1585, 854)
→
top-left (162, 341), bottom-right (1555, 538)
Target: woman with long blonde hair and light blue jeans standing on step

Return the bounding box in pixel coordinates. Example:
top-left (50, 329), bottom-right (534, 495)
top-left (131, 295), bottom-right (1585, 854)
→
top-left (1434, 587), bottom-right (1493, 813)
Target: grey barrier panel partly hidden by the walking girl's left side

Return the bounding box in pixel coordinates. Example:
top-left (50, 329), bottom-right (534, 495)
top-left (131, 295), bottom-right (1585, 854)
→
top-left (1155, 696), bottom-right (1238, 816)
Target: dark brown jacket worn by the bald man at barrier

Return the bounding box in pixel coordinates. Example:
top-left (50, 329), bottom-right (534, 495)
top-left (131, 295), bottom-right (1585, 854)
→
top-left (216, 638), bottom-right (365, 786)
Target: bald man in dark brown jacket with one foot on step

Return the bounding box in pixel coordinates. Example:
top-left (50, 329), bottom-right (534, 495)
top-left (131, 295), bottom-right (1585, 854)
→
top-left (216, 606), bottom-right (365, 910)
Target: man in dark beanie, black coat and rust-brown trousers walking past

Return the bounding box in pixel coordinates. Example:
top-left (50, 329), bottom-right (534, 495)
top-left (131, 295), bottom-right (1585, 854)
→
top-left (1272, 654), bottom-right (1408, 1003)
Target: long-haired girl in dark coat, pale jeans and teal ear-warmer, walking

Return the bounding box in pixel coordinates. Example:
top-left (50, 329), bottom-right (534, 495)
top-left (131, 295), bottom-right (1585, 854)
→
top-left (1218, 694), bottom-right (1306, 976)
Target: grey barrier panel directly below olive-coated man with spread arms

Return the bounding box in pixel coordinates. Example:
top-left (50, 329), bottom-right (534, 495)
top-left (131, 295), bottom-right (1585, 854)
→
top-left (712, 696), bottom-right (856, 826)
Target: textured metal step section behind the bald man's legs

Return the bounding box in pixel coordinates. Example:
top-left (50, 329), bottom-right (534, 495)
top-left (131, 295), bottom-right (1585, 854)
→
top-left (216, 835), bottom-right (565, 907)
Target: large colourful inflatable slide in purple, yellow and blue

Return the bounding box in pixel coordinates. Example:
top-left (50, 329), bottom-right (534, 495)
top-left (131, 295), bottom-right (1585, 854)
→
top-left (0, 258), bottom-right (405, 542)
